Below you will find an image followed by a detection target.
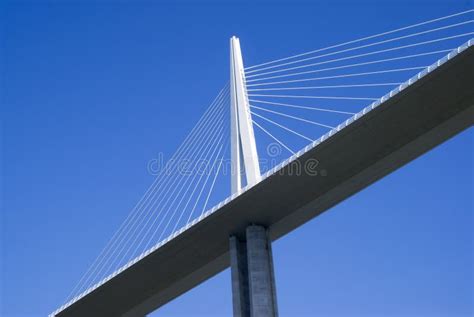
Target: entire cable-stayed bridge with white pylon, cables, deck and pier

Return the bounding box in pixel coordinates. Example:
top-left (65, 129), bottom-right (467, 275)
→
top-left (52, 10), bottom-right (474, 316)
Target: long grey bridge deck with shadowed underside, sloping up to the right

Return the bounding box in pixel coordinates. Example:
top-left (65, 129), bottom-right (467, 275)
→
top-left (53, 42), bottom-right (474, 317)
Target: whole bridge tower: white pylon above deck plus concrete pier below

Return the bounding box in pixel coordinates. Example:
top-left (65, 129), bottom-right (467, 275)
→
top-left (229, 36), bottom-right (278, 317)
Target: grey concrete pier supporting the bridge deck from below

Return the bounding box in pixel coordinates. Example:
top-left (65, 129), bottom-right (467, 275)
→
top-left (230, 225), bottom-right (278, 317)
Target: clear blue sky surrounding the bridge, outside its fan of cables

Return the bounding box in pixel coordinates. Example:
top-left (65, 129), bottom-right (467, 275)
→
top-left (0, 0), bottom-right (474, 317)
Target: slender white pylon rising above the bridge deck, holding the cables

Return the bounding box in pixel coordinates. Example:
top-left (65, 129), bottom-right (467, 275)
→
top-left (230, 36), bottom-right (261, 194)
